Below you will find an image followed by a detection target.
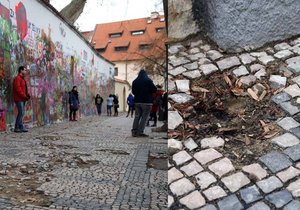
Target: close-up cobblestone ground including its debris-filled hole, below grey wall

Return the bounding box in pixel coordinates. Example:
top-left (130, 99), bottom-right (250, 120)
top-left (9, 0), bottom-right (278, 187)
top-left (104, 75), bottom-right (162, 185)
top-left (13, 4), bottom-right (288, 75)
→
top-left (168, 37), bottom-right (300, 210)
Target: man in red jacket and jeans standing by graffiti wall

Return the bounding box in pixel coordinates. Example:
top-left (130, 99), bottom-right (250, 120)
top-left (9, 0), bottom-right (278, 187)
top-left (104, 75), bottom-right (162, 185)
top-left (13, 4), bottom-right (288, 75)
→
top-left (13, 66), bottom-right (30, 133)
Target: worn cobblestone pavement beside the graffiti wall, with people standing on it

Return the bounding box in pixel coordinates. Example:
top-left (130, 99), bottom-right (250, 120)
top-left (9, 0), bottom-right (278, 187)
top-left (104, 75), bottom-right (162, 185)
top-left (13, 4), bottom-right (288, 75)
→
top-left (0, 115), bottom-right (167, 210)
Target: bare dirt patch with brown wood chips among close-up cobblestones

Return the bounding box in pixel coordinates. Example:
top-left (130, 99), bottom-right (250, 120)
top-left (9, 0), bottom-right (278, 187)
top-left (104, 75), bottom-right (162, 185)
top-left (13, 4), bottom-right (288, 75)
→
top-left (168, 72), bottom-right (284, 166)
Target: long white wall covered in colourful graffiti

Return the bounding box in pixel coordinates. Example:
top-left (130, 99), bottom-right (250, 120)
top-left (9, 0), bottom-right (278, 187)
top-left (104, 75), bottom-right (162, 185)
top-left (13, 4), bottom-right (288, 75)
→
top-left (0, 0), bottom-right (114, 131)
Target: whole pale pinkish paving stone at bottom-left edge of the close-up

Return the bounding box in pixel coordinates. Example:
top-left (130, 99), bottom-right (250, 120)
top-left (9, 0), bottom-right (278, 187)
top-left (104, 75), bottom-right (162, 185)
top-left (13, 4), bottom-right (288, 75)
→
top-left (179, 190), bottom-right (206, 209)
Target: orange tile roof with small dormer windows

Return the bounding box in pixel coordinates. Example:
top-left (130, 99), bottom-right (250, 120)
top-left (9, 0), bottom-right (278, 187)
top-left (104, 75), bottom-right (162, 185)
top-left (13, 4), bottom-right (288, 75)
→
top-left (91, 15), bottom-right (167, 61)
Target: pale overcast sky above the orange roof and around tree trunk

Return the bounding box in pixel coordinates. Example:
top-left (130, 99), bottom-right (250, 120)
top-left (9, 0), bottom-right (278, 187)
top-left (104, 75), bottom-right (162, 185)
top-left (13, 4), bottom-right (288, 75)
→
top-left (50, 0), bottom-right (163, 31)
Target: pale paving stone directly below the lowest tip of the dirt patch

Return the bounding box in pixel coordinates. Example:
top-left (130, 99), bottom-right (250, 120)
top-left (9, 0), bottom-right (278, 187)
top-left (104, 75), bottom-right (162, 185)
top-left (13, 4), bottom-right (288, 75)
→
top-left (221, 172), bottom-right (250, 192)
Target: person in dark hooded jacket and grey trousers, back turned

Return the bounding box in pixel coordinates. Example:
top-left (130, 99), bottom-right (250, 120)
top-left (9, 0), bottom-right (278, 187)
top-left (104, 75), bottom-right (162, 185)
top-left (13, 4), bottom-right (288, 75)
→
top-left (131, 69), bottom-right (157, 137)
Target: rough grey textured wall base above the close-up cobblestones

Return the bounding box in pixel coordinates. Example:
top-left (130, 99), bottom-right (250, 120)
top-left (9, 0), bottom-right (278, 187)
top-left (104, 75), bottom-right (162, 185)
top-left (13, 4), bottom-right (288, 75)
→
top-left (192, 0), bottom-right (300, 52)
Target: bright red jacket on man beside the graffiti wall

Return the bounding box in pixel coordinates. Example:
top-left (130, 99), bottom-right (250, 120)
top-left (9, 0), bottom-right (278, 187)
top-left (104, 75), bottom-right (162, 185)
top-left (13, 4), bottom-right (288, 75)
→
top-left (13, 74), bottom-right (30, 102)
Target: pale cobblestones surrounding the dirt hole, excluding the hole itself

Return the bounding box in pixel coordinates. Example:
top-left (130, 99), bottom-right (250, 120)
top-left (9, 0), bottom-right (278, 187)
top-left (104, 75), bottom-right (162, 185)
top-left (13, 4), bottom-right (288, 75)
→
top-left (168, 38), bottom-right (300, 210)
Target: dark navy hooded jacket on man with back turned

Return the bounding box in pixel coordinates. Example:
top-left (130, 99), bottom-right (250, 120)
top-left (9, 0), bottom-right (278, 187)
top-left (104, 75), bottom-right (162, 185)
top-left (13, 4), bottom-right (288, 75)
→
top-left (132, 70), bottom-right (157, 104)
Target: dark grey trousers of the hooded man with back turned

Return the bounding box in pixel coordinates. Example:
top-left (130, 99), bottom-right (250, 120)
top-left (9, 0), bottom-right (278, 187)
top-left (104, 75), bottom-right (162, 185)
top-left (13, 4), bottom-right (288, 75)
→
top-left (131, 103), bottom-right (152, 134)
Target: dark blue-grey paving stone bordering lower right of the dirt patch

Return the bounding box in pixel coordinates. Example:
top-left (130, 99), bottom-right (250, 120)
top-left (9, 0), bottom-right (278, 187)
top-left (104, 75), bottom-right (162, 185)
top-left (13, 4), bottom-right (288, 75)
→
top-left (259, 152), bottom-right (292, 173)
